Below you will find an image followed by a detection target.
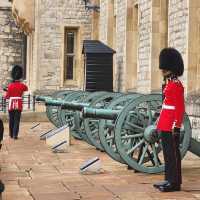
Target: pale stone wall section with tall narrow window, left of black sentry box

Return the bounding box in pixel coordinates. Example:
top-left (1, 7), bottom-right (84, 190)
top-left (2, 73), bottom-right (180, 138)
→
top-left (8, 0), bottom-right (92, 93)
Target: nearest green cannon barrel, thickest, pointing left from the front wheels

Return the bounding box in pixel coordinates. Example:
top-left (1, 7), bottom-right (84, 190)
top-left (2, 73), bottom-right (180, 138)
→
top-left (82, 107), bottom-right (120, 120)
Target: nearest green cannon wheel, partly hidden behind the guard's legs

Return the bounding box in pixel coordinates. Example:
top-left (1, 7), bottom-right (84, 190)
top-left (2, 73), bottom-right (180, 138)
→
top-left (115, 94), bottom-right (191, 173)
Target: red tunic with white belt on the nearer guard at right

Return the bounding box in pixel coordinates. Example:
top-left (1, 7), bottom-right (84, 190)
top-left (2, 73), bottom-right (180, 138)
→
top-left (157, 79), bottom-right (185, 132)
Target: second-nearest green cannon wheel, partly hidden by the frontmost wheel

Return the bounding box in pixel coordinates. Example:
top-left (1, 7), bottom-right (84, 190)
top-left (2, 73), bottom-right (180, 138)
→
top-left (99, 93), bottom-right (141, 164)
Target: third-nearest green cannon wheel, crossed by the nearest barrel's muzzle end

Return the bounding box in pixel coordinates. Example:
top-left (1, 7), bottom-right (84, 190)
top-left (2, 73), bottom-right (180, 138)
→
top-left (83, 93), bottom-right (122, 151)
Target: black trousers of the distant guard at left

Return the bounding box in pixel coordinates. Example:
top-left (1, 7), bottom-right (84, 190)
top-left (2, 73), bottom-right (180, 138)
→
top-left (9, 110), bottom-right (21, 138)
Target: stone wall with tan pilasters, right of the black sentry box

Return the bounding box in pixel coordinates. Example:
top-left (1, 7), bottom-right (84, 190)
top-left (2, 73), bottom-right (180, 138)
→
top-left (96, 0), bottom-right (200, 94)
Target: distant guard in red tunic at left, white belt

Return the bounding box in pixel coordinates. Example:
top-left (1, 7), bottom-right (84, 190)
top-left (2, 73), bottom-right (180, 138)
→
top-left (5, 65), bottom-right (28, 139)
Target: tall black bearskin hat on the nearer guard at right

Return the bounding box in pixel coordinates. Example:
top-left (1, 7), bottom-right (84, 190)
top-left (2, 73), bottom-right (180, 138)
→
top-left (159, 48), bottom-right (184, 76)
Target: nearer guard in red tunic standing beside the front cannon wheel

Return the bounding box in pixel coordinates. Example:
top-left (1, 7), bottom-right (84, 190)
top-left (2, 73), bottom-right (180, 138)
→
top-left (154, 48), bottom-right (185, 192)
